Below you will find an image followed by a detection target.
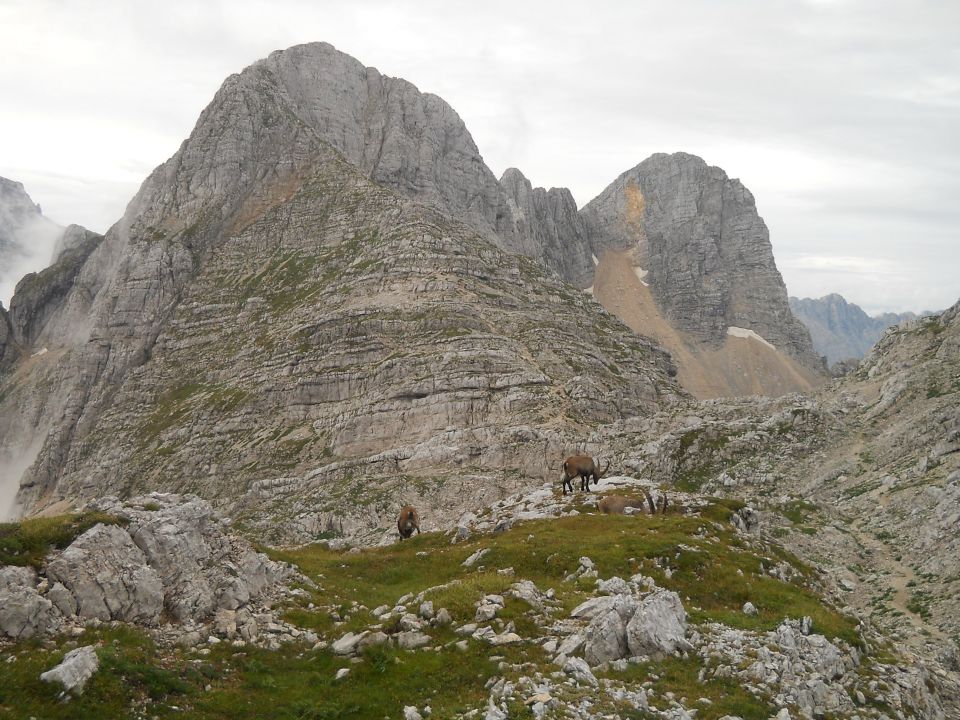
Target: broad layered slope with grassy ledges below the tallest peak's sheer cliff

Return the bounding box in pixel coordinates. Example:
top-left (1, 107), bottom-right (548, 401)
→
top-left (0, 46), bottom-right (684, 539)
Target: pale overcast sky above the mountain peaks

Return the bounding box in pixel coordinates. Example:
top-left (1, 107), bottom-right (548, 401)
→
top-left (0, 0), bottom-right (960, 313)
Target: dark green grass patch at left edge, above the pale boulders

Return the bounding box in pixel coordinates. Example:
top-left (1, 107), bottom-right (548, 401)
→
top-left (0, 512), bottom-right (126, 569)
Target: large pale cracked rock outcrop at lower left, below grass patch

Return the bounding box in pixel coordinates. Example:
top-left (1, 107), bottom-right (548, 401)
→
top-left (0, 493), bottom-right (293, 639)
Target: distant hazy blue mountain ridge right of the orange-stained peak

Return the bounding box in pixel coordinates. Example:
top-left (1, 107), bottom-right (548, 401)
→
top-left (790, 293), bottom-right (930, 365)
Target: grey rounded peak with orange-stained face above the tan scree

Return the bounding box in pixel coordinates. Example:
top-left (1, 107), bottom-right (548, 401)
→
top-left (581, 153), bottom-right (820, 368)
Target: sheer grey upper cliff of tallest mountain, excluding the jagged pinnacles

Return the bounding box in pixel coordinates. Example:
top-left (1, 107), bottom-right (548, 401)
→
top-left (240, 43), bottom-right (510, 249)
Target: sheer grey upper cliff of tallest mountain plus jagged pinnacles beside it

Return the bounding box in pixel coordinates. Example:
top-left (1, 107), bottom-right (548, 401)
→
top-left (246, 43), bottom-right (608, 287)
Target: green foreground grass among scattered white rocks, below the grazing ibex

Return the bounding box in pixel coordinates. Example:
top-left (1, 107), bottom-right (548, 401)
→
top-left (0, 504), bottom-right (857, 720)
